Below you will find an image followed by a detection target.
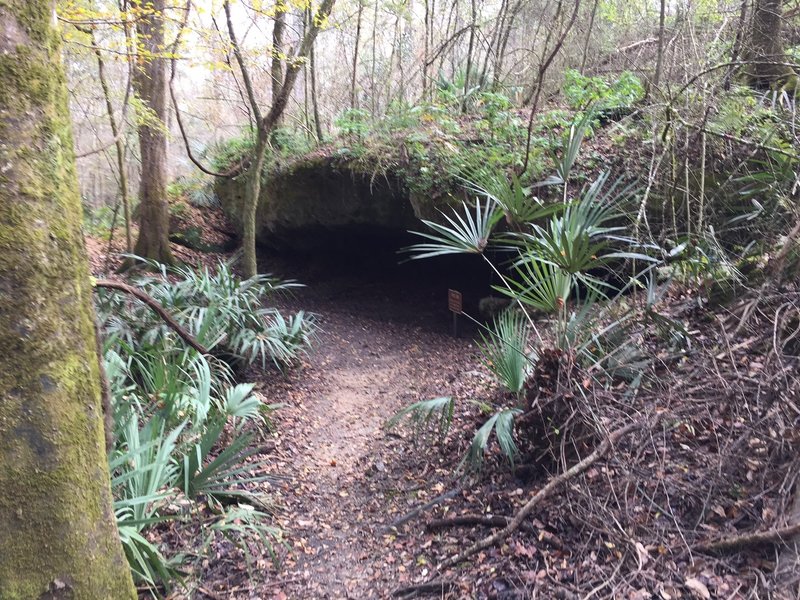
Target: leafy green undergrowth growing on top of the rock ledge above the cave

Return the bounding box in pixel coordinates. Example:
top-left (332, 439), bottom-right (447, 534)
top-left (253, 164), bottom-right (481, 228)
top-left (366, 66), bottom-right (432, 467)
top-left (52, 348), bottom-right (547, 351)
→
top-left (214, 71), bottom-right (644, 204)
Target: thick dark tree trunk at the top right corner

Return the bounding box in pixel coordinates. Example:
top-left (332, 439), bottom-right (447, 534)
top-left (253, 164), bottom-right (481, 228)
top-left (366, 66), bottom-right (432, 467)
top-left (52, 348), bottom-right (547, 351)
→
top-left (744, 0), bottom-right (797, 90)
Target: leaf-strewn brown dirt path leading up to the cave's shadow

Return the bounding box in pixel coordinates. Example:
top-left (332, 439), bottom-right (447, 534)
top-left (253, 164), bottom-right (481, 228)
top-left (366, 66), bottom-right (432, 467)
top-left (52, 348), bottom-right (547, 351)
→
top-left (259, 282), bottom-right (474, 598)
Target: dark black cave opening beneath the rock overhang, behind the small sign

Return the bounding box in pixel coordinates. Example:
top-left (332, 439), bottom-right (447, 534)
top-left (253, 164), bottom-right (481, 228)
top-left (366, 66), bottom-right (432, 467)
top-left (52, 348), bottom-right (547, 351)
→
top-left (259, 223), bottom-right (498, 335)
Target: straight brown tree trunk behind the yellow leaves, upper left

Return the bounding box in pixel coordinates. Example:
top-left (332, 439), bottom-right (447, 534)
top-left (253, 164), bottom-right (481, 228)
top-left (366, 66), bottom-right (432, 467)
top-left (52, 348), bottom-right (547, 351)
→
top-left (132, 0), bottom-right (174, 264)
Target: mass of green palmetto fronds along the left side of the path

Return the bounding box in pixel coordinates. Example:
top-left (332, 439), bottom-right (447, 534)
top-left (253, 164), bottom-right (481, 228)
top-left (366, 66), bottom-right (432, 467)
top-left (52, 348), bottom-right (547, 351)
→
top-left (97, 261), bottom-right (316, 594)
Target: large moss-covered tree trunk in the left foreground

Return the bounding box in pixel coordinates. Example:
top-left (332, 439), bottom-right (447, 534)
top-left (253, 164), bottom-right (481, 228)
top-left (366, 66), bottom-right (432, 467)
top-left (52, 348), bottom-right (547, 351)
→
top-left (0, 0), bottom-right (136, 600)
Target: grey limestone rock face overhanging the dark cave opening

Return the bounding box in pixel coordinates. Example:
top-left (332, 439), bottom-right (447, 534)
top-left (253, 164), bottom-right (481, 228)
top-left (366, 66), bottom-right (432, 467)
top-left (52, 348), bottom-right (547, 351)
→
top-left (212, 158), bottom-right (427, 251)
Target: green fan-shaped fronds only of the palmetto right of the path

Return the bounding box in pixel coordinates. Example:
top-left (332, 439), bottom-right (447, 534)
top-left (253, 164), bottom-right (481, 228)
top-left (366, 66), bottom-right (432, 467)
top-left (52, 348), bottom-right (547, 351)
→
top-left (390, 111), bottom-right (657, 465)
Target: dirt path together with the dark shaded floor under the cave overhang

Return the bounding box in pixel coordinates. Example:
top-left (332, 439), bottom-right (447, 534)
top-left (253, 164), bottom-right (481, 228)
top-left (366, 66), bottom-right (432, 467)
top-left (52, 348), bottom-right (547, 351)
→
top-left (187, 254), bottom-right (486, 598)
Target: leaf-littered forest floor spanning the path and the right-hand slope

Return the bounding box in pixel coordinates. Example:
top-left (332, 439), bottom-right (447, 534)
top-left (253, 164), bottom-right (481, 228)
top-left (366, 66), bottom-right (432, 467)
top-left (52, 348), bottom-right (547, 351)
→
top-left (90, 203), bottom-right (800, 600)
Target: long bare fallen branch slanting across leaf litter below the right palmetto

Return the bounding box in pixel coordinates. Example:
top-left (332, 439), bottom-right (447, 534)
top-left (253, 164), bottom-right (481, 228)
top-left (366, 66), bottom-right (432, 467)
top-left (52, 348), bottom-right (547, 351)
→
top-left (440, 421), bottom-right (644, 569)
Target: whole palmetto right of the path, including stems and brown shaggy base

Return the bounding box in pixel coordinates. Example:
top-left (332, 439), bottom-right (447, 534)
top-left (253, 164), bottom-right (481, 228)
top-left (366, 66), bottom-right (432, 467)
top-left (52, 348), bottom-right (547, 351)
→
top-left (390, 111), bottom-right (664, 467)
